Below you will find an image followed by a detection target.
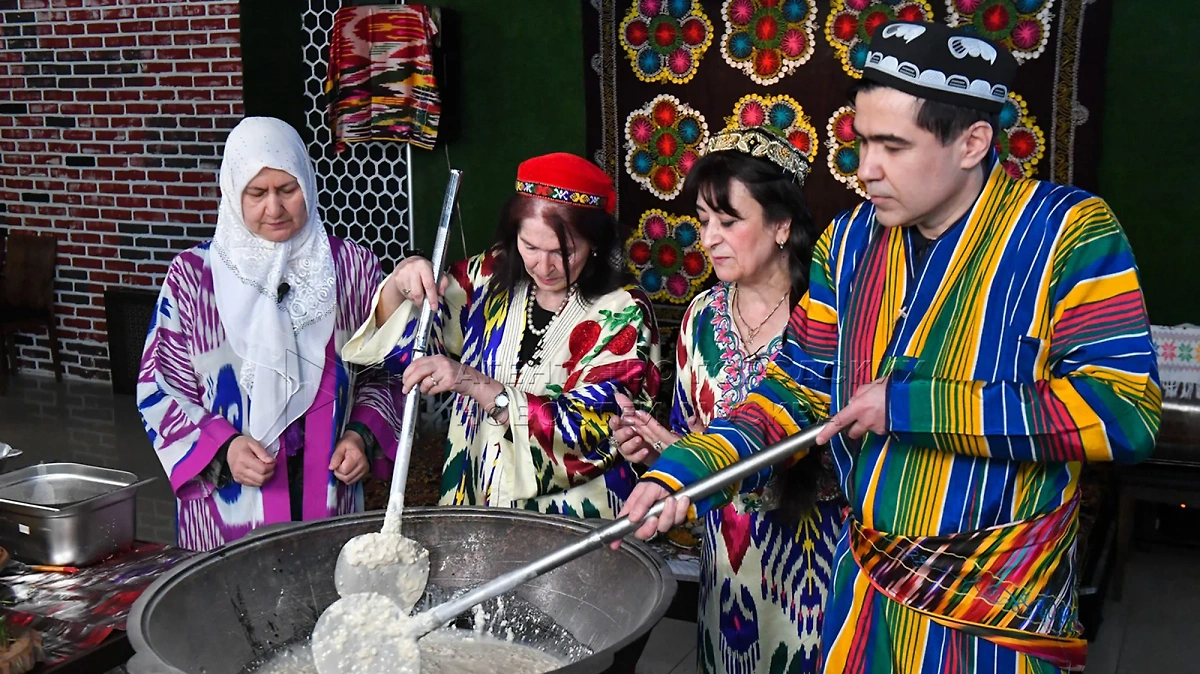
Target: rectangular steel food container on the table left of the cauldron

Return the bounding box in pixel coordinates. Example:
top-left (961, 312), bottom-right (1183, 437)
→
top-left (0, 463), bottom-right (150, 566)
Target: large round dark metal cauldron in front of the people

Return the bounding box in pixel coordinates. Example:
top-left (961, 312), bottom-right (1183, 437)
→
top-left (127, 507), bottom-right (676, 674)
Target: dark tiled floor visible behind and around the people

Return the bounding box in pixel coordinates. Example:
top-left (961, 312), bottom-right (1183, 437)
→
top-left (0, 375), bottom-right (1200, 674)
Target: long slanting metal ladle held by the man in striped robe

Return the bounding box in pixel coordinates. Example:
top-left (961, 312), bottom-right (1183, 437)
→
top-left (312, 423), bottom-right (824, 674)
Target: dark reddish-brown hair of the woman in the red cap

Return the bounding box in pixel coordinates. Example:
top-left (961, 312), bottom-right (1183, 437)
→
top-left (492, 194), bottom-right (632, 302)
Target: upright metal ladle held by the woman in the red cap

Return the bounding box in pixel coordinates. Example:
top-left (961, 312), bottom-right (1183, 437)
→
top-left (322, 169), bottom-right (462, 619)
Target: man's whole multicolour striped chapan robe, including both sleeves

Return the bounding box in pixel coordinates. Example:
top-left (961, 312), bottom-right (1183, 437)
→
top-left (649, 154), bottom-right (1162, 673)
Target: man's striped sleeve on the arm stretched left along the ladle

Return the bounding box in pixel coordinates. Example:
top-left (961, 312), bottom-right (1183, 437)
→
top-left (643, 227), bottom-right (838, 517)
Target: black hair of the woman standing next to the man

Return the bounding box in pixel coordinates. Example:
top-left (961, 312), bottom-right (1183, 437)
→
top-left (683, 151), bottom-right (822, 523)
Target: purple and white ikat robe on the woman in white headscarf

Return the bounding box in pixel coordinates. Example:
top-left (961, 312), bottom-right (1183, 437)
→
top-left (137, 234), bottom-right (402, 550)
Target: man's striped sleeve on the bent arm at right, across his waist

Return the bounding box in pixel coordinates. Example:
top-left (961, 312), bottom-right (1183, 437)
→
top-left (888, 198), bottom-right (1162, 463)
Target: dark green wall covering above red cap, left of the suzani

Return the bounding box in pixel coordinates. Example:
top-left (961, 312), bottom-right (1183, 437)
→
top-left (413, 0), bottom-right (586, 260)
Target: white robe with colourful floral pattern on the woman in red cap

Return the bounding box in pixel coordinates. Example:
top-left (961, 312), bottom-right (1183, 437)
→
top-left (342, 249), bottom-right (659, 518)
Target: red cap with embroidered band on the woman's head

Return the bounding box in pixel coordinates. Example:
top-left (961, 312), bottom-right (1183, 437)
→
top-left (517, 152), bottom-right (617, 213)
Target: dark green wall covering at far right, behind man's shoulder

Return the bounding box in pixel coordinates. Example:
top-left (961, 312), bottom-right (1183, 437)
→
top-left (1099, 0), bottom-right (1200, 325)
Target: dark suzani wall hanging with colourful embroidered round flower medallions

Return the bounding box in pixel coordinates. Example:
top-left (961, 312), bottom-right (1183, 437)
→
top-left (582, 0), bottom-right (1112, 316)
